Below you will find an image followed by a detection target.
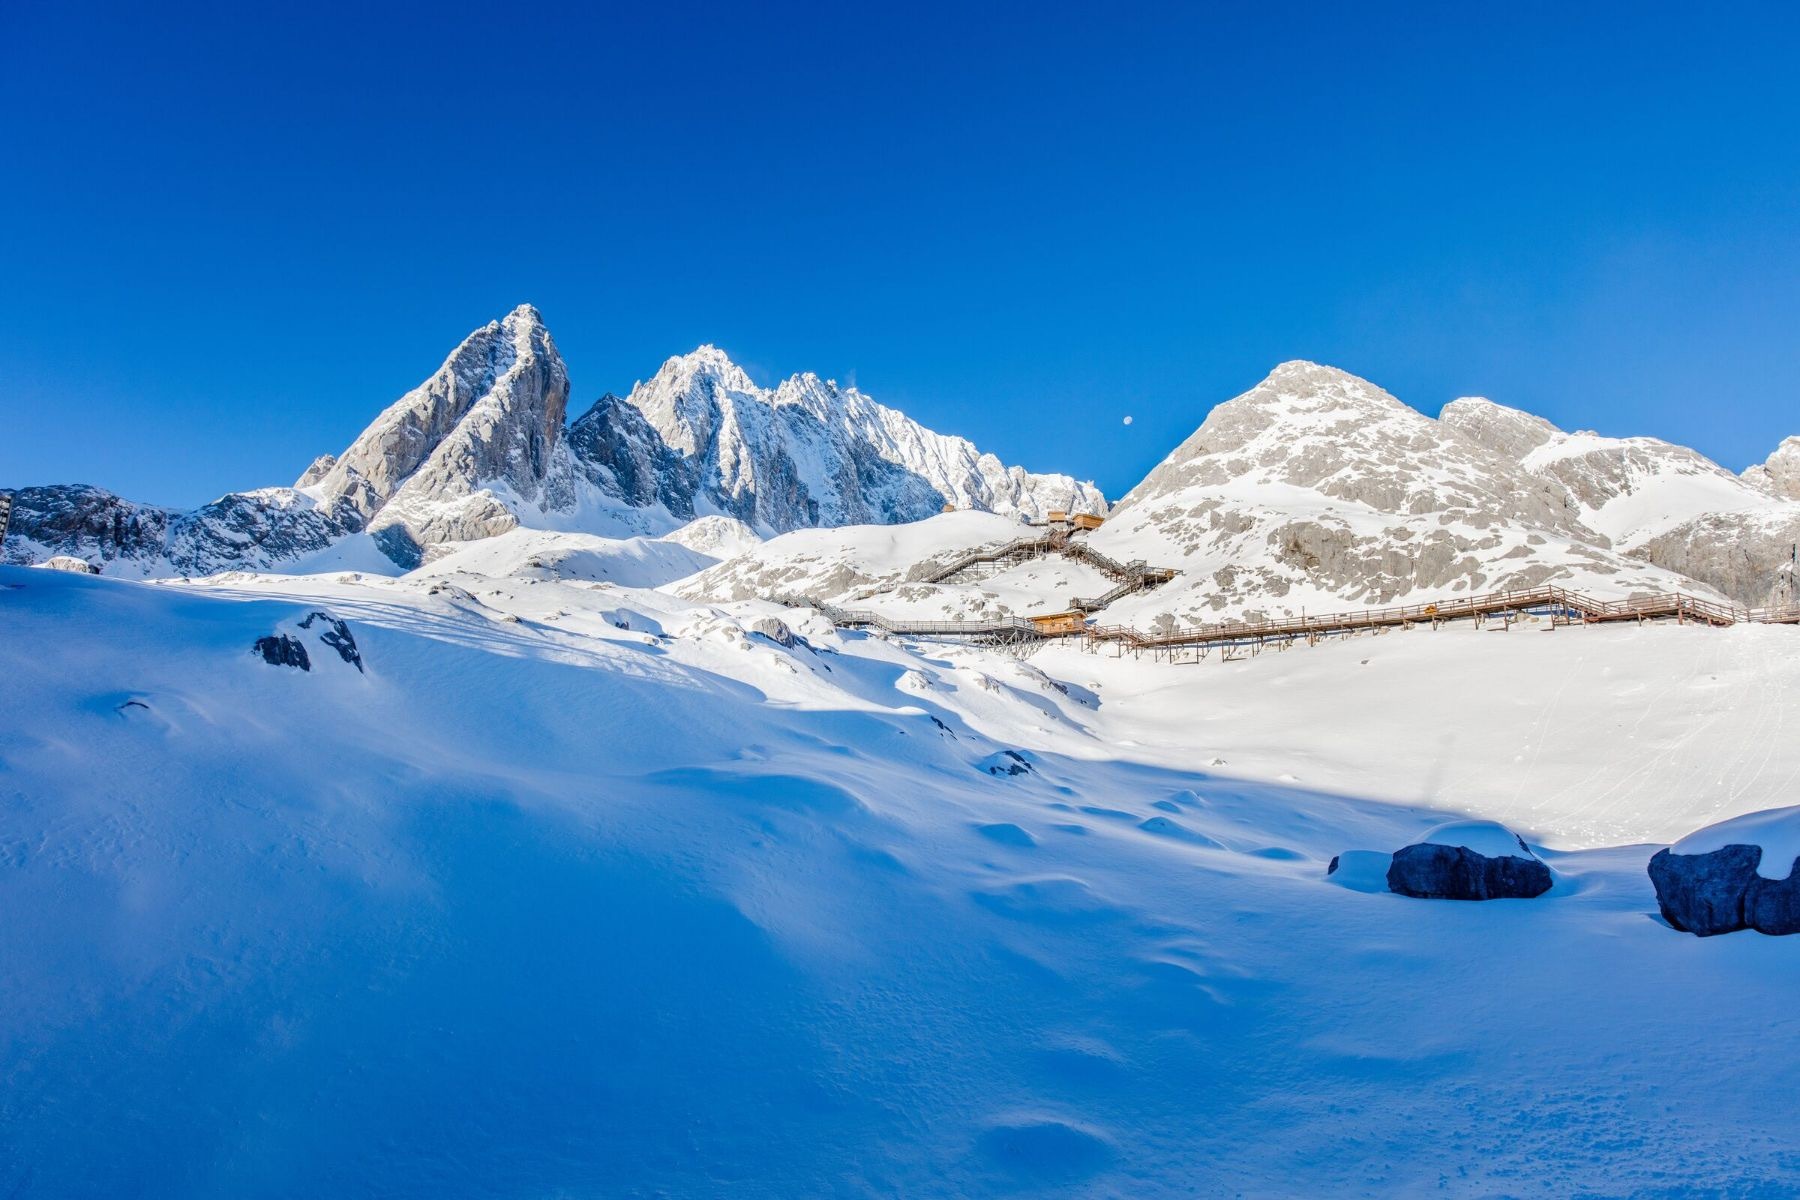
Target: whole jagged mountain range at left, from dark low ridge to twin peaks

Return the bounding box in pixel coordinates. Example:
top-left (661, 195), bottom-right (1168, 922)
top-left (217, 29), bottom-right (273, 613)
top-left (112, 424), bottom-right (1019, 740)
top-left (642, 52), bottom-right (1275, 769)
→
top-left (5, 304), bottom-right (1105, 576)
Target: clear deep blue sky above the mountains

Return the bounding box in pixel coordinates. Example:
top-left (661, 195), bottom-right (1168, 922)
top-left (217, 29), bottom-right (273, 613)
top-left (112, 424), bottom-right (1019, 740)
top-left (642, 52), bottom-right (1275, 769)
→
top-left (0, 0), bottom-right (1800, 506)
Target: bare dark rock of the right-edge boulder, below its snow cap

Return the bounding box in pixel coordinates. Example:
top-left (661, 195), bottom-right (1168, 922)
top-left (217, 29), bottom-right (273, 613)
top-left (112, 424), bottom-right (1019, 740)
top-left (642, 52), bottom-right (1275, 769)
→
top-left (1649, 846), bottom-right (1800, 937)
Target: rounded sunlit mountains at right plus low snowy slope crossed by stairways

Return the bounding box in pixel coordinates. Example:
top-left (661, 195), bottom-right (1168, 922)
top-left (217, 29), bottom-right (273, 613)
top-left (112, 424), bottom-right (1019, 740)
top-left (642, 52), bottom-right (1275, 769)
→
top-left (679, 362), bottom-right (1800, 626)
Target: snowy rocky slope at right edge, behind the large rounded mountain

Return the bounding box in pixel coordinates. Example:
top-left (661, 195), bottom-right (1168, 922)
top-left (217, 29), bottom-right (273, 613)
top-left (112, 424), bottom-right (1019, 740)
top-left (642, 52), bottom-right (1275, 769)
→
top-left (1440, 398), bottom-right (1800, 604)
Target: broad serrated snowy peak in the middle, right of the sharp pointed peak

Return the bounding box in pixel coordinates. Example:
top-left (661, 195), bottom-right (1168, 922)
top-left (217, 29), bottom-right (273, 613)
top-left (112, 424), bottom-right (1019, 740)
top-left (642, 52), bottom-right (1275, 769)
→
top-left (604, 345), bottom-right (1105, 533)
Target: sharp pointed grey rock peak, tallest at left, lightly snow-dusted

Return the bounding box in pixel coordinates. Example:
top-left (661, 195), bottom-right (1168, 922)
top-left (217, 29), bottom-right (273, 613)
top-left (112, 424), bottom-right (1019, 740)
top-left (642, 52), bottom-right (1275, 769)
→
top-left (306, 304), bottom-right (576, 567)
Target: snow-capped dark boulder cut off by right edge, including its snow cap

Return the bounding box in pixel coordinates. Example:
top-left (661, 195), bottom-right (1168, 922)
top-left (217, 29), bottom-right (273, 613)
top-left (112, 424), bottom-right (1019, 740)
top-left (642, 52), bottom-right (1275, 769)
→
top-left (1651, 808), bottom-right (1800, 937)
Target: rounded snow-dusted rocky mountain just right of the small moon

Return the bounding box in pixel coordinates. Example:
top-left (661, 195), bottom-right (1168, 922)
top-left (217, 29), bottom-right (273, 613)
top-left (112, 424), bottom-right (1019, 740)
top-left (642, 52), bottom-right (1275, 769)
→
top-left (1093, 362), bottom-right (1694, 624)
